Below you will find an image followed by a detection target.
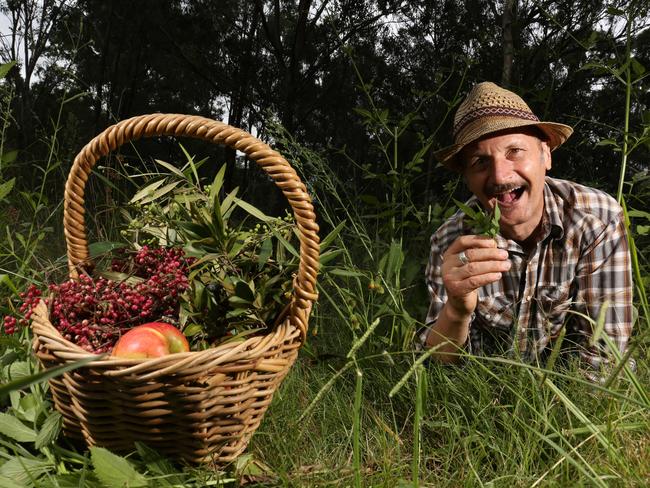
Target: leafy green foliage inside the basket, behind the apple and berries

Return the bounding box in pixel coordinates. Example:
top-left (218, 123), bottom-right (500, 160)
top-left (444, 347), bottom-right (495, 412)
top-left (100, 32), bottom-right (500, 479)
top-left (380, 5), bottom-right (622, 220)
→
top-left (122, 157), bottom-right (299, 348)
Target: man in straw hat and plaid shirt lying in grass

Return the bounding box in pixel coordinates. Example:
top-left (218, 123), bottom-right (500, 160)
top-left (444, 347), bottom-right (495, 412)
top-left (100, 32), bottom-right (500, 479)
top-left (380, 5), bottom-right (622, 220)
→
top-left (420, 82), bottom-right (633, 380)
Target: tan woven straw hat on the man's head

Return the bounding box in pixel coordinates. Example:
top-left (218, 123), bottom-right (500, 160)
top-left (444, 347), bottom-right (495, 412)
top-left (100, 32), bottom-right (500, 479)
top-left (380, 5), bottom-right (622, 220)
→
top-left (434, 81), bottom-right (573, 170)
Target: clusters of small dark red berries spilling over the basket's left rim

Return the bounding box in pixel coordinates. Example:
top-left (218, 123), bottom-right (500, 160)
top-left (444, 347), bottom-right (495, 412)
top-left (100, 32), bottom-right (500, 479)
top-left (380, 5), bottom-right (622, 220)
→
top-left (4, 246), bottom-right (193, 353)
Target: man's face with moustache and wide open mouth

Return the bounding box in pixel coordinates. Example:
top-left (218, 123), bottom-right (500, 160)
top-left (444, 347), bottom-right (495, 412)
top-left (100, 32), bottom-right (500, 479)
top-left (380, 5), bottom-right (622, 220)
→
top-left (461, 129), bottom-right (551, 242)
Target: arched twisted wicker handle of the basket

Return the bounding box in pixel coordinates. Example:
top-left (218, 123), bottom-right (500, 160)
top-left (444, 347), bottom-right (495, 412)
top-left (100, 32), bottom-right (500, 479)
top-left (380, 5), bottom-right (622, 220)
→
top-left (63, 114), bottom-right (320, 340)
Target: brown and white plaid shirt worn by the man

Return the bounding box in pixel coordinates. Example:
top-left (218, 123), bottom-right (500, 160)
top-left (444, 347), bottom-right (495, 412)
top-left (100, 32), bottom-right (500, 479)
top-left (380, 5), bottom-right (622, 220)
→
top-left (420, 177), bottom-right (633, 380)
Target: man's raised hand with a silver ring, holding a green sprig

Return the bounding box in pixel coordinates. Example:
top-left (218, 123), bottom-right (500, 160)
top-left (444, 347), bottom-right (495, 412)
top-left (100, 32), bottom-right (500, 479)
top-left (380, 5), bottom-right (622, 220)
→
top-left (442, 235), bottom-right (511, 316)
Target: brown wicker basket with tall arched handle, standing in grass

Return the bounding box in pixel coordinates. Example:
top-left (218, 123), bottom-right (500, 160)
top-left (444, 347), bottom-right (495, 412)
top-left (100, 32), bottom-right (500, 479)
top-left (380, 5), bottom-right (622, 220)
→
top-left (32, 114), bottom-right (319, 467)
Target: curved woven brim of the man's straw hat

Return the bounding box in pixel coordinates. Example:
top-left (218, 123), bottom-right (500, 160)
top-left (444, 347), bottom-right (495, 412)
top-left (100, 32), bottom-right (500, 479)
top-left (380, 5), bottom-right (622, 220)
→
top-left (433, 117), bottom-right (573, 171)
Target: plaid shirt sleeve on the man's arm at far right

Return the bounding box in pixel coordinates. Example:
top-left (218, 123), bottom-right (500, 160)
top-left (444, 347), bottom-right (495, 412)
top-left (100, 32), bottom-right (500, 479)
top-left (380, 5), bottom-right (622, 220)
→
top-left (576, 213), bottom-right (634, 381)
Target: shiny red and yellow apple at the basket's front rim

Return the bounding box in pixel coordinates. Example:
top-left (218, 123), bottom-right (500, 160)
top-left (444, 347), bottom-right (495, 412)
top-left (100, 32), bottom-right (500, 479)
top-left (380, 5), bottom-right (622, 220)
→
top-left (112, 322), bottom-right (190, 359)
